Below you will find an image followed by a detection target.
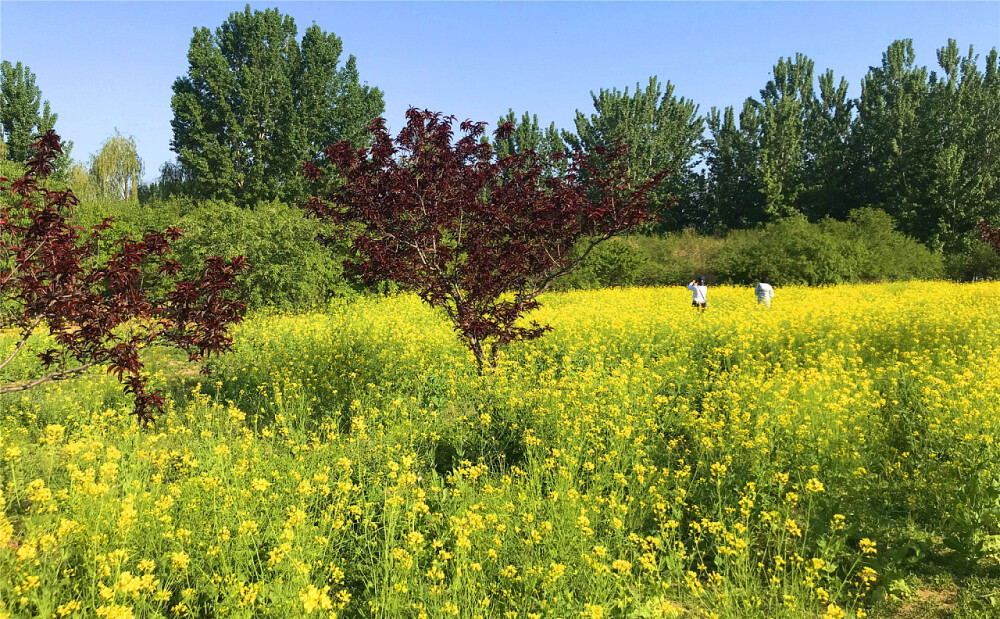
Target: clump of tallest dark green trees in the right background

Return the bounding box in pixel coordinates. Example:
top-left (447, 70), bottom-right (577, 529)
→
top-left (698, 39), bottom-right (1000, 253)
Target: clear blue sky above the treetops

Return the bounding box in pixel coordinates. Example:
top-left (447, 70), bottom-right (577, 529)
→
top-left (0, 0), bottom-right (1000, 179)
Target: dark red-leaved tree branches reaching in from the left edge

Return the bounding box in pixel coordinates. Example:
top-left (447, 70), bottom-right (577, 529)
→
top-left (0, 131), bottom-right (249, 424)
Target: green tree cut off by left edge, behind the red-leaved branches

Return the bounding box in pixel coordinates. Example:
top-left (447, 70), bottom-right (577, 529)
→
top-left (0, 60), bottom-right (73, 174)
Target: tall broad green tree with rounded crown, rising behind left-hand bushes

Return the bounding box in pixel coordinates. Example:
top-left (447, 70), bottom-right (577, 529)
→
top-left (171, 5), bottom-right (384, 206)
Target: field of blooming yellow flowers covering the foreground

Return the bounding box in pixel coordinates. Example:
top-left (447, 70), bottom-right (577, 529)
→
top-left (0, 282), bottom-right (1000, 619)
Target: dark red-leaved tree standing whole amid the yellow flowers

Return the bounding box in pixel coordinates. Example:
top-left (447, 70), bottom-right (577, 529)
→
top-left (303, 108), bottom-right (666, 373)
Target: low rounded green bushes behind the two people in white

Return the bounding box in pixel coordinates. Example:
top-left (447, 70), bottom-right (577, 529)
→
top-left (562, 208), bottom-right (944, 288)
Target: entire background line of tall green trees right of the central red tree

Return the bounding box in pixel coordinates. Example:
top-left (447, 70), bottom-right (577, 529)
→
top-left (501, 39), bottom-right (1000, 252)
